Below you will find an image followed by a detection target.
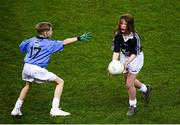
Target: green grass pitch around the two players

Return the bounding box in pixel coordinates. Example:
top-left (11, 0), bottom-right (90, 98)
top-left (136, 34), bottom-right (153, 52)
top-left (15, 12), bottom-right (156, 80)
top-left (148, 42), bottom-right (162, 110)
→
top-left (0, 0), bottom-right (180, 124)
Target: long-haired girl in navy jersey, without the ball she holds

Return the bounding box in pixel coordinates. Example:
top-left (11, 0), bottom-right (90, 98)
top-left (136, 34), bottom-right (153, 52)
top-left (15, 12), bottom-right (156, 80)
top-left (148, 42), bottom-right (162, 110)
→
top-left (112, 14), bottom-right (151, 116)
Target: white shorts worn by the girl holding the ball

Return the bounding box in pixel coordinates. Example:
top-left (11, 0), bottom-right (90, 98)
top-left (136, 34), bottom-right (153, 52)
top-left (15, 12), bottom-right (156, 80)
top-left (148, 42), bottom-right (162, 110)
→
top-left (120, 52), bottom-right (144, 74)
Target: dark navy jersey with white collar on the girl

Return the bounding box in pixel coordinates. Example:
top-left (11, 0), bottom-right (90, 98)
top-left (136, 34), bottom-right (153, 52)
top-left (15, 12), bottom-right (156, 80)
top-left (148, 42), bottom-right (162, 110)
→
top-left (113, 33), bottom-right (142, 56)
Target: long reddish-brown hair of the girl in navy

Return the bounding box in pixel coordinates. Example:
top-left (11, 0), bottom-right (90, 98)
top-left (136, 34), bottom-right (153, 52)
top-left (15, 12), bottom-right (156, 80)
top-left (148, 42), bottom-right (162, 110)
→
top-left (114, 14), bottom-right (135, 34)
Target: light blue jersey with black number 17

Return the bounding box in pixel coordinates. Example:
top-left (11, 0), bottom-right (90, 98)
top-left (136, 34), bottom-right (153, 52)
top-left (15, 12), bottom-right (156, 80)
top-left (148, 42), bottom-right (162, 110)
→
top-left (19, 36), bottom-right (64, 67)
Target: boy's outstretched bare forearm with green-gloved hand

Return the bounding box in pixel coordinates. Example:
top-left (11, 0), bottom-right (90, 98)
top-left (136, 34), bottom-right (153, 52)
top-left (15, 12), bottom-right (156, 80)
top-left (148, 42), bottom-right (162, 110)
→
top-left (63, 32), bottom-right (92, 45)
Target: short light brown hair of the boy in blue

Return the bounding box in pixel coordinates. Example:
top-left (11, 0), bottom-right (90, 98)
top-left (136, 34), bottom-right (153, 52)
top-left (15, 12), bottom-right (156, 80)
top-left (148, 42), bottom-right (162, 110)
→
top-left (35, 22), bottom-right (52, 34)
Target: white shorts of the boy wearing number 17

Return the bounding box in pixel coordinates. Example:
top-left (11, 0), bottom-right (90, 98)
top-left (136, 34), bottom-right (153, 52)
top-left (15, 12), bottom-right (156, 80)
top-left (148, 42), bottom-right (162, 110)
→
top-left (22, 63), bottom-right (57, 83)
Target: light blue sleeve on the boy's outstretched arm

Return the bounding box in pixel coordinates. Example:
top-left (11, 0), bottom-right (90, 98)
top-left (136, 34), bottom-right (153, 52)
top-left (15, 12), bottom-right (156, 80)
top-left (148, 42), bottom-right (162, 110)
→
top-left (51, 40), bottom-right (64, 53)
